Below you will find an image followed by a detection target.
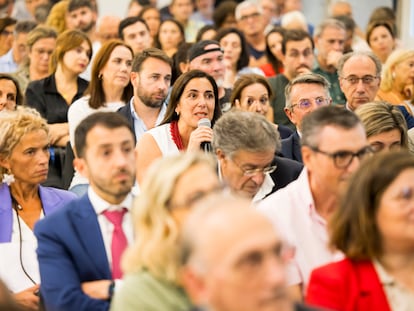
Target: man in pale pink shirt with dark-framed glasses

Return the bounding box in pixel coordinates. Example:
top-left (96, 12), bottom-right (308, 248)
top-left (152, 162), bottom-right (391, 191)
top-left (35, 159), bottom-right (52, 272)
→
top-left (258, 106), bottom-right (372, 300)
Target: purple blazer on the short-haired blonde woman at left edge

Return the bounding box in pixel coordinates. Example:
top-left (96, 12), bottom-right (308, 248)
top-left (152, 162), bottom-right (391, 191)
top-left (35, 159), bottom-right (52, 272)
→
top-left (0, 183), bottom-right (76, 243)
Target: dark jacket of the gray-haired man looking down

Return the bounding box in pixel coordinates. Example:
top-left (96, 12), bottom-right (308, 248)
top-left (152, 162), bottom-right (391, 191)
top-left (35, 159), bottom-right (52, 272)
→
top-left (269, 156), bottom-right (303, 195)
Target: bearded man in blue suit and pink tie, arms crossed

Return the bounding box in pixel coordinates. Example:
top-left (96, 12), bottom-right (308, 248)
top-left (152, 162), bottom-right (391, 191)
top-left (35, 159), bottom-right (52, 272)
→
top-left (35, 112), bottom-right (135, 311)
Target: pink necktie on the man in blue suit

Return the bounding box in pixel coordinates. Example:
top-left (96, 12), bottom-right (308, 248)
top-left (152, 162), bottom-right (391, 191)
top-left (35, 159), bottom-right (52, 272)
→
top-left (103, 208), bottom-right (128, 280)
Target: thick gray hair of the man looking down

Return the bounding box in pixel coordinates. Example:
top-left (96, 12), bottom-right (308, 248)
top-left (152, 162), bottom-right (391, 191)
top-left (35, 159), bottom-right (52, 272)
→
top-left (212, 110), bottom-right (281, 156)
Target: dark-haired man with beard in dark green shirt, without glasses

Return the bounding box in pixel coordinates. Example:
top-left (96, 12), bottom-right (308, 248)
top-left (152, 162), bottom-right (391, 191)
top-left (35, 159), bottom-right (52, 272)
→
top-left (269, 30), bottom-right (314, 130)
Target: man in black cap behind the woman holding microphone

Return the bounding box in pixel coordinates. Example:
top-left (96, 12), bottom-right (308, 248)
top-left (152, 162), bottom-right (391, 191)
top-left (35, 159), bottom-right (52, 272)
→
top-left (188, 40), bottom-right (231, 112)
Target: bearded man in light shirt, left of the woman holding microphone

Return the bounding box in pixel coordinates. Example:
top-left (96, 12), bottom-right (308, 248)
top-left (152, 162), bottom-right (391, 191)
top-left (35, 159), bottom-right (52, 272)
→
top-left (118, 48), bottom-right (172, 141)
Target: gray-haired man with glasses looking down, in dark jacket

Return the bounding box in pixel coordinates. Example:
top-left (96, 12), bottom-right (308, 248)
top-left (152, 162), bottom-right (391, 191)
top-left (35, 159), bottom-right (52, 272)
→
top-left (212, 111), bottom-right (302, 202)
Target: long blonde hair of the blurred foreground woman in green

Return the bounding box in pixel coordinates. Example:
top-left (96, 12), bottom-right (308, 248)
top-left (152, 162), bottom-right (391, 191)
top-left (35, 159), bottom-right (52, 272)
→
top-left (122, 153), bottom-right (215, 283)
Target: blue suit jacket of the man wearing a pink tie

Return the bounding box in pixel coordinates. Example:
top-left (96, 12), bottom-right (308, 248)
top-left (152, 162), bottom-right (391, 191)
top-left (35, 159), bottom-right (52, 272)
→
top-left (34, 195), bottom-right (112, 311)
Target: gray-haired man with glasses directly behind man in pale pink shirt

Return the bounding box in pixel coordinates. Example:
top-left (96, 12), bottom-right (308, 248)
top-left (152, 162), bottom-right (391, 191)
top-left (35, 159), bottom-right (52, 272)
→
top-left (282, 73), bottom-right (332, 162)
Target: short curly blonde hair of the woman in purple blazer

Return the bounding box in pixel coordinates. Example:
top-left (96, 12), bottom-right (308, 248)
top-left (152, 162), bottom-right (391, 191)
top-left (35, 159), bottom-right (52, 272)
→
top-left (0, 106), bottom-right (49, 179)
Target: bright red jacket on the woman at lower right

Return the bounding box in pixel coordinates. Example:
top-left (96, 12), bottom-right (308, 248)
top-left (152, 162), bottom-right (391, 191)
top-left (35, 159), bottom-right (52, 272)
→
top-left (306, 259), bottom-right (391, 311)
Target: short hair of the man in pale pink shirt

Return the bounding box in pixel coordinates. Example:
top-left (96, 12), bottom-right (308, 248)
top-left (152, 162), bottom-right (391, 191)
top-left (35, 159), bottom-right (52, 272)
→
top-left (301, 106), bottom-right (363, 147)
